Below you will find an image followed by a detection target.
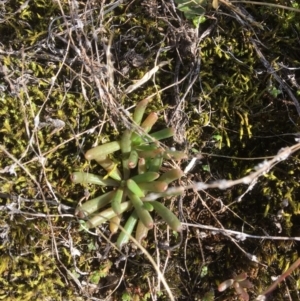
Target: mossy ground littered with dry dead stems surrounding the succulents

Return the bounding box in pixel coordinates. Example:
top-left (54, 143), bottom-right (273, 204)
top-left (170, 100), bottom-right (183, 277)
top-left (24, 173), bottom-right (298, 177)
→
top-left (0, 0), bottom-right (300, 301)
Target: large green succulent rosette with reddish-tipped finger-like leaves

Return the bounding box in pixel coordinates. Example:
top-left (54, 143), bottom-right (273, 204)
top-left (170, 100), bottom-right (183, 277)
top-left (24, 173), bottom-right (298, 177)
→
top-left (71, 99), bottom-right (186, 248)
